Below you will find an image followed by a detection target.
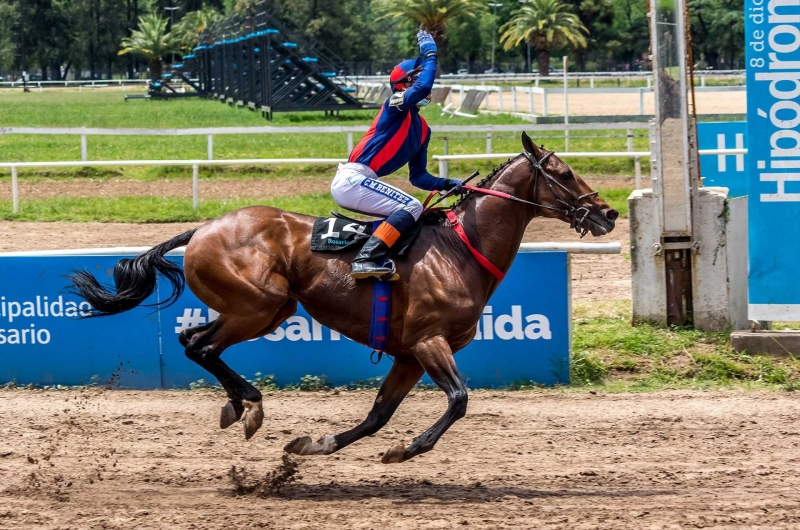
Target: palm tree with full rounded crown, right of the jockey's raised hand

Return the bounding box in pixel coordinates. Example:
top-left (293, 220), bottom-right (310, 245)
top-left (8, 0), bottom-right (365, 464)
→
top-left (500, 0), bottom-right (589, 76)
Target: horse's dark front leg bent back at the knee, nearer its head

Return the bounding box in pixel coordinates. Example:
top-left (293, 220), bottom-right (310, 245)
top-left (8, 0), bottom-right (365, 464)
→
top-left (381, 336), bottom-right (468, 464)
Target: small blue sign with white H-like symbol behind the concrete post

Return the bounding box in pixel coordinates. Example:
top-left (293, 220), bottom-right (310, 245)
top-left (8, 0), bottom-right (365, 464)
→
top-left (697, 121), bottom-right (748, 197)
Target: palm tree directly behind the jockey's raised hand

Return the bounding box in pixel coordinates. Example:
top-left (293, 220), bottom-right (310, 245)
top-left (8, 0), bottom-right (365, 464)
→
top-left (378, 0), bottom-right (486, 68)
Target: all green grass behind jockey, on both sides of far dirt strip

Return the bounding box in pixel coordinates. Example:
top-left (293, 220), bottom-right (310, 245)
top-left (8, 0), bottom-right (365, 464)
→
top-left (0, 89), bottom-right (636, 222)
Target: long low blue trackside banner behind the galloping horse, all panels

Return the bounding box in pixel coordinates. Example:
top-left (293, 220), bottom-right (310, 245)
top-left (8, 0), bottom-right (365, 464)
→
top-left (0, 252), bottom-right (570, 388)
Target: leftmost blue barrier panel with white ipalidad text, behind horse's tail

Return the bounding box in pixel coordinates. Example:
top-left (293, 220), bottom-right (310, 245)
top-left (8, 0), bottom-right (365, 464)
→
top-left (0, 256), bottom-right (161, 388)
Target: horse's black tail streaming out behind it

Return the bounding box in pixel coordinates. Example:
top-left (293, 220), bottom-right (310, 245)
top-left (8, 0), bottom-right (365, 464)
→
top-left (67, 228), bottom-right (197, 317)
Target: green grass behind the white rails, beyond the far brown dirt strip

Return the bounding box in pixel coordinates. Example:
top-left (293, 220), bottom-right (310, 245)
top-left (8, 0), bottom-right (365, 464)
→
top-left (0, 90), bottom-right (648, 178)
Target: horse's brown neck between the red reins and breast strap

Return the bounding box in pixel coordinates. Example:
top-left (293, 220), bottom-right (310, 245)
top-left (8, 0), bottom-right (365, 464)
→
top-left (460, 161), bottom-right (533, 284)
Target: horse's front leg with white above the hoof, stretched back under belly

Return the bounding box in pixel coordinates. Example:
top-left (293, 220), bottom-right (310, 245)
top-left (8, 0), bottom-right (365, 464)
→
top-left (284, 359), bottom-right (423, 455)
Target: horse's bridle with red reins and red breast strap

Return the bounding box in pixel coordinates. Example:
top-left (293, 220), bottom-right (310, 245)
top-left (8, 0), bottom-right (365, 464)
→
top-left (422, 149), bottom-right (598, 280)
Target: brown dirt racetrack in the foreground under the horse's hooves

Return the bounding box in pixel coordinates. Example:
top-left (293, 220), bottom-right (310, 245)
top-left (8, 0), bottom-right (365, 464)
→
top-left (0, 389), bottom-right (800, 530)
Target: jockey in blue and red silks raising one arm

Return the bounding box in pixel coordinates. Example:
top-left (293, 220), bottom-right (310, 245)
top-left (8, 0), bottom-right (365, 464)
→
top-left (331, 31), bottom-right (461, 281)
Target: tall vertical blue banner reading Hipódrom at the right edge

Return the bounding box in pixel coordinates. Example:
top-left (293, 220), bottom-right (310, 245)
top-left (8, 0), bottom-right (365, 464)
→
top-left (745, 0), bottom-right (800, 320)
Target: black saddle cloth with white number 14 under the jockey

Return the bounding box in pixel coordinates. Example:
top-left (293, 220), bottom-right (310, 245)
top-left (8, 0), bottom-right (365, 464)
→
top-left (311, 212), bottom-right (423, 257)
